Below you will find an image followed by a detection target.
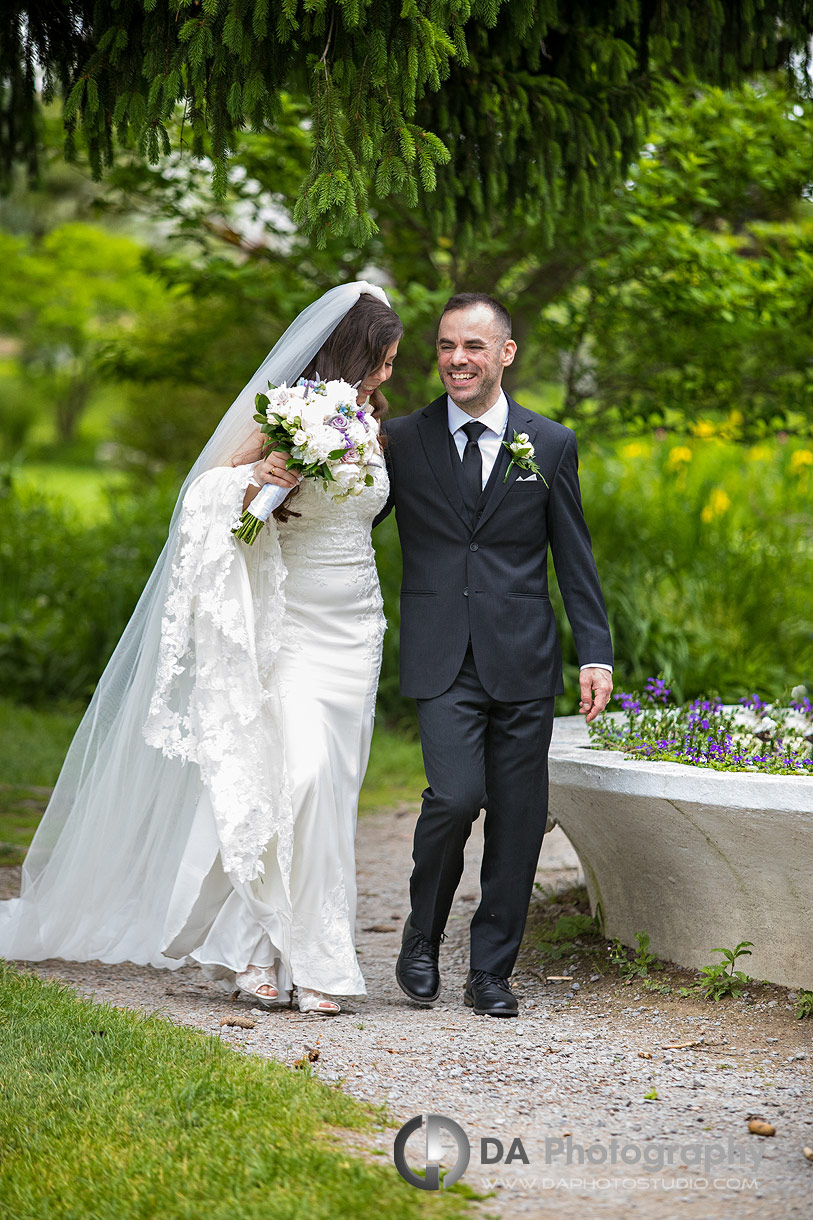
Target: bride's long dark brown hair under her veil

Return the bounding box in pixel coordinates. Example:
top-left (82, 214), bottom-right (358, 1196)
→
top-left (273, 293), bottom-right (404, 521)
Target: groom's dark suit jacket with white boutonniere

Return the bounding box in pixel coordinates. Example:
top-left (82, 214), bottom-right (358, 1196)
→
top-left (375, 394), bottom-right (613, 703)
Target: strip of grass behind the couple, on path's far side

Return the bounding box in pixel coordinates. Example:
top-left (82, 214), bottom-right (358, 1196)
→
top-left (0, 699), bottom-right (417, 866)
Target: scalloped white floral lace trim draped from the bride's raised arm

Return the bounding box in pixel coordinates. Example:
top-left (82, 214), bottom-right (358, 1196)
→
top-left (144, 465), bottom-right (293, 881)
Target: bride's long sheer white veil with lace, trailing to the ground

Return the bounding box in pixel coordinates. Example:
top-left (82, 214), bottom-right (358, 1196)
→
top-left (0, 281), bottom-right (388, 969)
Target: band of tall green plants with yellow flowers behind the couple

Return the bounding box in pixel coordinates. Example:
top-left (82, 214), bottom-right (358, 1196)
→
top-left (0, 438), bottom-right (813, 730)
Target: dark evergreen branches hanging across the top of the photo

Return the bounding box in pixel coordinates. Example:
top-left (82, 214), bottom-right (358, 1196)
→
top-left (0, 0), bottom-right (813, 244)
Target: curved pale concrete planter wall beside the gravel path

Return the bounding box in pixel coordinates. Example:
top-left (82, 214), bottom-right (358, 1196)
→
top-left (549, 716), bottom-right (813, 989)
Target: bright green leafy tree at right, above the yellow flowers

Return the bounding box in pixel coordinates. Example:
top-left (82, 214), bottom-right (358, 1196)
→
top-left (535, 83), bottom-right (813, 438)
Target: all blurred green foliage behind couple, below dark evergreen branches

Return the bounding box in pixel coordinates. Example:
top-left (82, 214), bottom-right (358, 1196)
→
top-left (0, 78), bottom-right (813, 728)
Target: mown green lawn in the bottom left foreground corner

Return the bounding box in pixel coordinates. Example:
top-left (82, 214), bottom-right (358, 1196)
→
top-left (0, 961), bottom-right (466, 1220)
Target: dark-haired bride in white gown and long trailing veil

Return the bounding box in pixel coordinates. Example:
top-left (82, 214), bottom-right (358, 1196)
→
top-left (0, 282), bottom-right (402, 1014)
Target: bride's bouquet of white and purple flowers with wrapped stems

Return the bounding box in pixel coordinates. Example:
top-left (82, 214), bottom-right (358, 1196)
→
top-left (232, 377), bottom-right (376, 545)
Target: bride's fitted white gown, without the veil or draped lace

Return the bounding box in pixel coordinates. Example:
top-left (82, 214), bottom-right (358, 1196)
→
top-left (156, 464), bottom-right (388, 996)
